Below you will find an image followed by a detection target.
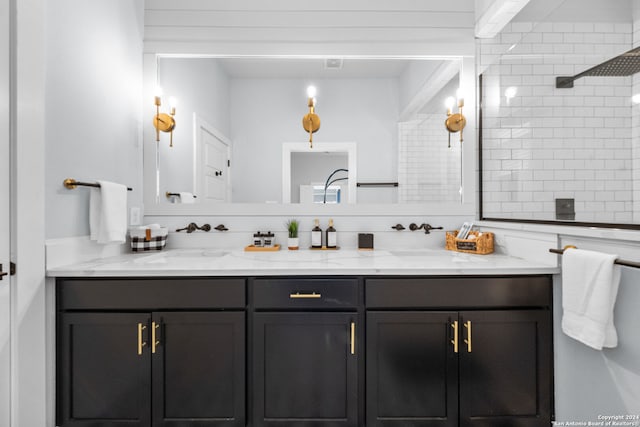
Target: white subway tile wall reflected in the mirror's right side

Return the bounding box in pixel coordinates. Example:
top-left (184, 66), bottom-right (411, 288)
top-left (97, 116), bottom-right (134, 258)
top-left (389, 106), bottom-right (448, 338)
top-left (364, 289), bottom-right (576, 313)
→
top-left (398, 114), bottom-right (464, 203)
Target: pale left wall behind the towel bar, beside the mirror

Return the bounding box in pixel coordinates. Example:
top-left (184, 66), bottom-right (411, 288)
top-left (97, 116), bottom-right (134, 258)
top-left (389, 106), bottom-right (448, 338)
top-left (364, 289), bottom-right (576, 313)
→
top-left (45, 0), bottom-right (144, 238)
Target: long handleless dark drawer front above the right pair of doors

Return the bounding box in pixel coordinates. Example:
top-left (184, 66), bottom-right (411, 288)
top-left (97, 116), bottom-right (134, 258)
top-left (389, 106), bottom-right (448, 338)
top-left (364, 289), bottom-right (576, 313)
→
top-left (365, 276), bottom-right (552, 309)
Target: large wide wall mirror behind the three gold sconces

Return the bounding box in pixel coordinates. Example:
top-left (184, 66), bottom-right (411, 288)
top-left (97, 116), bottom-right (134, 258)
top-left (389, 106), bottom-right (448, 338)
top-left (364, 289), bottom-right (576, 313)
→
top-left (144, 54), bottom-right (475, 215)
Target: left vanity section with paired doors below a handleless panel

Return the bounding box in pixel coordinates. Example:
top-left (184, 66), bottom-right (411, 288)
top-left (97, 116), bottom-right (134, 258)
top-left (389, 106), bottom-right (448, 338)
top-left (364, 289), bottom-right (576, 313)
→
top-left (57, 279), bottom-right (246, 427)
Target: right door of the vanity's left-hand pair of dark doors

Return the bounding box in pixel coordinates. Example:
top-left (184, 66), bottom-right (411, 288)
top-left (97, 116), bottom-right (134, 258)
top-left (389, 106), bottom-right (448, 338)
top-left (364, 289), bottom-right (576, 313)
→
top-left (151, 312), bottom-right (245, 427)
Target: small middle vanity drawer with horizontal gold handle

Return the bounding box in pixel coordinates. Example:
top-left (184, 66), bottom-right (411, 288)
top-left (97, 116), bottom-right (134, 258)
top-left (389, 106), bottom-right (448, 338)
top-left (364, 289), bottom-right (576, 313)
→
top-left (252, 278), bottom-right (358, 310)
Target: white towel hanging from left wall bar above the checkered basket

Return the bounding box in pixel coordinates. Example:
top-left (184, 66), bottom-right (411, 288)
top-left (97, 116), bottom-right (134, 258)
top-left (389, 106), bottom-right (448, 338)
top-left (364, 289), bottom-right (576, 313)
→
top-left (89, 181), bottom-right (127, 243)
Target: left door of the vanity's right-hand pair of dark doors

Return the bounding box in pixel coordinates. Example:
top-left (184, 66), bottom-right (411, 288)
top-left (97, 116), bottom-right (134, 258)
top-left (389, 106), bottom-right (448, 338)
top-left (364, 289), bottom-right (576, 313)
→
top-left (366, 311), bottom-right (458, 427)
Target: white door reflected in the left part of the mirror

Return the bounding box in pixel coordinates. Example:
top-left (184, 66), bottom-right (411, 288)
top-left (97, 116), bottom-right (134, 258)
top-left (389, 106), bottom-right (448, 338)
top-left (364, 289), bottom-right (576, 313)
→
top-left (194, 115), bottom-right (231, 203)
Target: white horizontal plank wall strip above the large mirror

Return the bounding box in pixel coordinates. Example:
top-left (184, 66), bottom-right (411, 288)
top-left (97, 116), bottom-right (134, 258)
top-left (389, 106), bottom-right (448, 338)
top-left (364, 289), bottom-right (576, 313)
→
top-left (144, 0), bottom-right (475, 56)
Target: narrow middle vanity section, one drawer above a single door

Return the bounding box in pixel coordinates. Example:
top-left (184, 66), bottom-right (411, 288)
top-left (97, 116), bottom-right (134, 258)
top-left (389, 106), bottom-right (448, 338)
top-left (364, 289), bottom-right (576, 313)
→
top-left (252, 278), bottom-right (362, 427)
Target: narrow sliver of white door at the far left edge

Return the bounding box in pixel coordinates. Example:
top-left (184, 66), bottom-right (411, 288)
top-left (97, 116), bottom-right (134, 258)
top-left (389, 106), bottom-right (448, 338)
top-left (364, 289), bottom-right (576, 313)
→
top-left (0, 0), bottom-right (11, 426)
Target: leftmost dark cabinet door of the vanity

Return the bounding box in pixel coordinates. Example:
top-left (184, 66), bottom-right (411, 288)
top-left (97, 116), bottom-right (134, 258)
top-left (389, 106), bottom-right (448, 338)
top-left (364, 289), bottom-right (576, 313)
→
top-left (58, 313), bottom-right (151, 427)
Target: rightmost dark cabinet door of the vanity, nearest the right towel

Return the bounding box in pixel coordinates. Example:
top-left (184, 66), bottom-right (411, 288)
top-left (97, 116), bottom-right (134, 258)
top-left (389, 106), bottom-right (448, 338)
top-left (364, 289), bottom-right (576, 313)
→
top-left (460, 310), bottom-right (552, 427)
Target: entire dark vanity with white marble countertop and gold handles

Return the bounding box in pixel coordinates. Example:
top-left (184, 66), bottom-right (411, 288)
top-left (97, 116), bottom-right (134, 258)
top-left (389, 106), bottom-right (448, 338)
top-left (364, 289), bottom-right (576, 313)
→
top-left (50, 251), bottom-right (556, 427)
